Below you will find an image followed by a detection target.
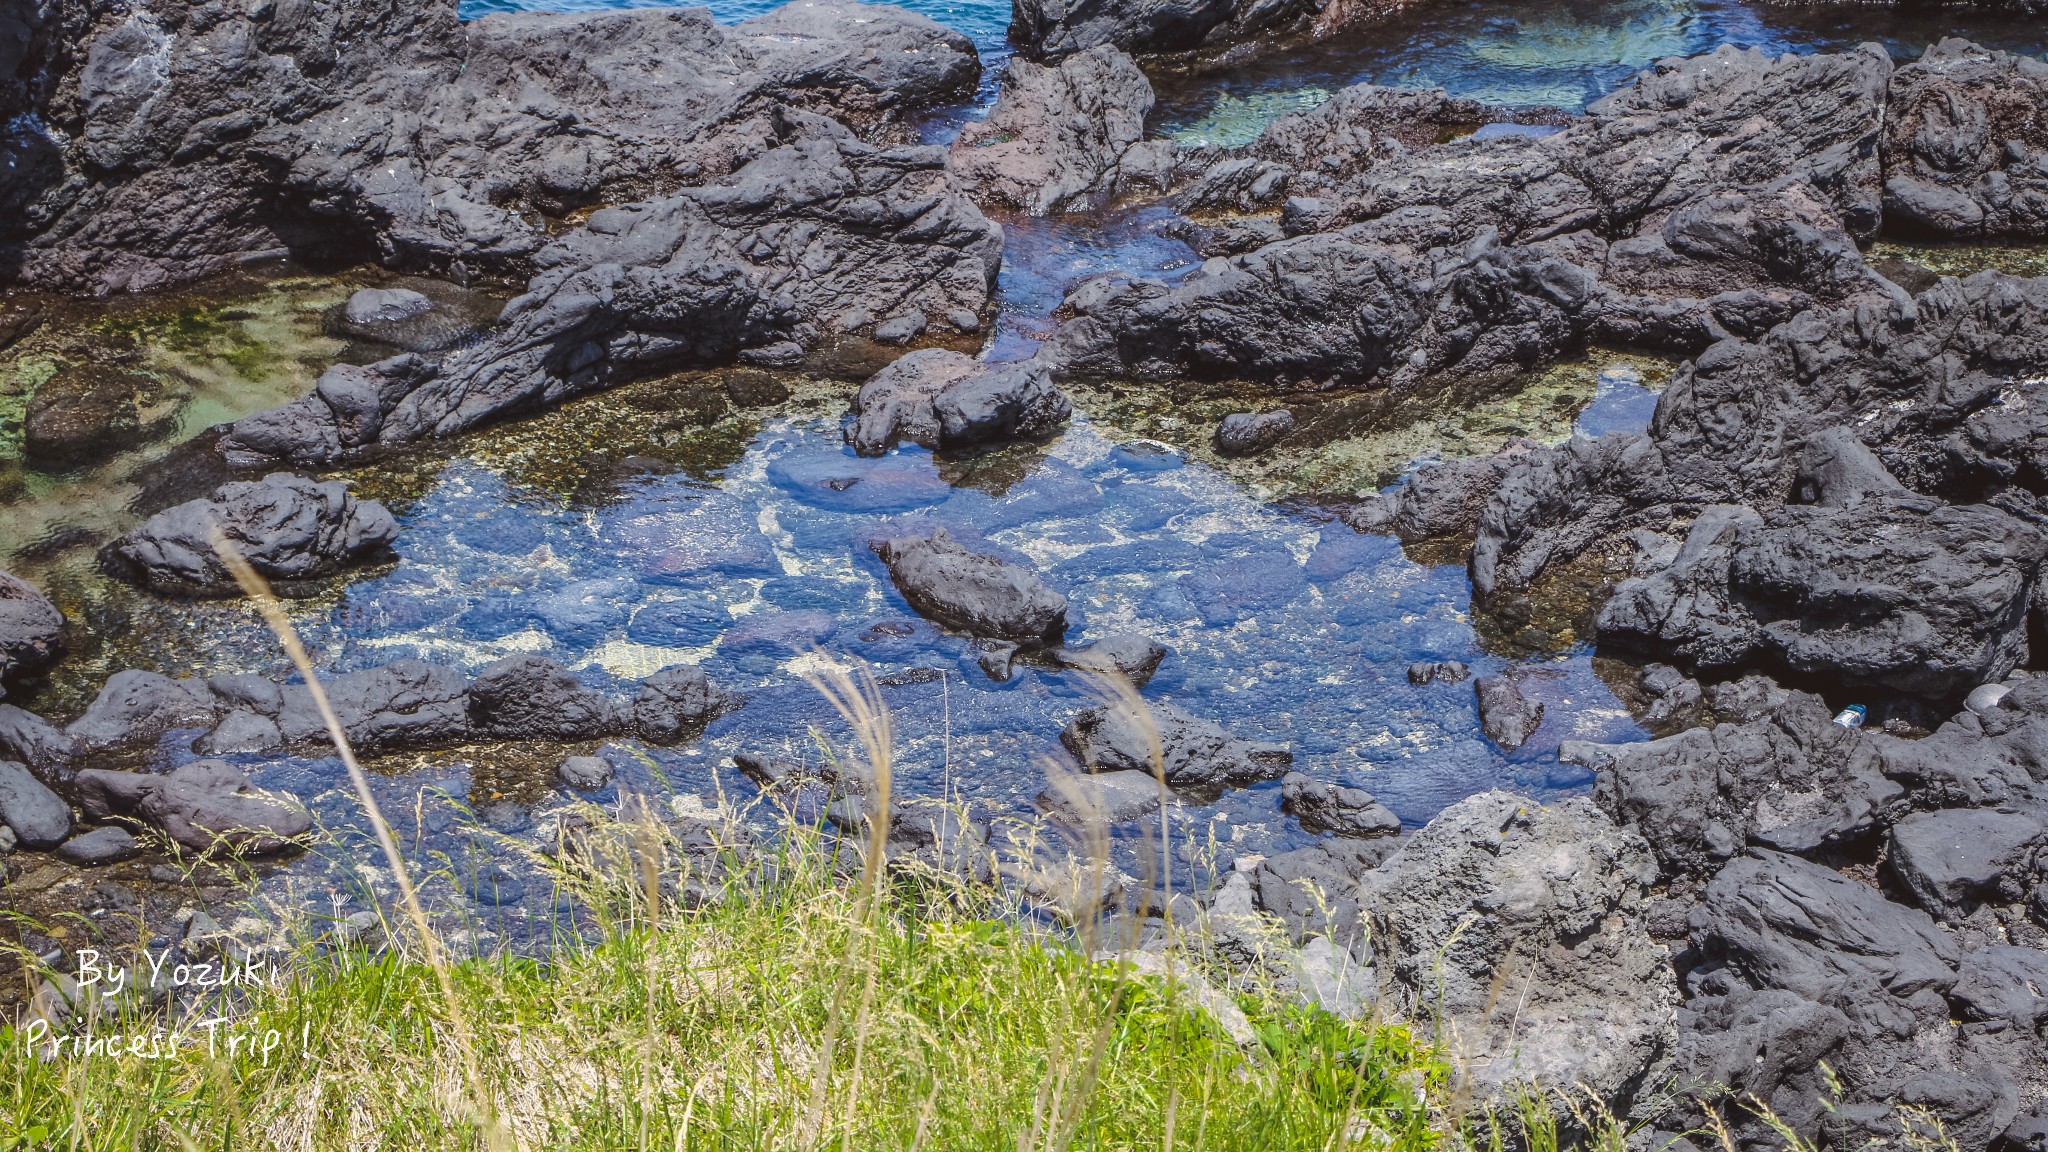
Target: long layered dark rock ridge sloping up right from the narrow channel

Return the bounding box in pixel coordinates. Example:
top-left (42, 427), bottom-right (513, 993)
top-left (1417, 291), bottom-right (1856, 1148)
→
top-left (1044, 45), bottom-right (1905, 389)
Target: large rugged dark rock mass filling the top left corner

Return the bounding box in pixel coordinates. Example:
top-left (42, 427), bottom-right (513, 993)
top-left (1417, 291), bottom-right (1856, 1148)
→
top-left (0, 0), bottom-right (979, 291)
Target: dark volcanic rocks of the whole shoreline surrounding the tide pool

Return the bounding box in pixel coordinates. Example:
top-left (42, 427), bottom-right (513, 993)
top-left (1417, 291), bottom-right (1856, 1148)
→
top-left (0, 0), bottom-right (2048, 1152)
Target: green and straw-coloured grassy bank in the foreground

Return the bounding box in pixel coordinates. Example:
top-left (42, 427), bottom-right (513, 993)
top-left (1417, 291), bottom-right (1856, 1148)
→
top-left (0, 803), bottom-right (1446, 1152)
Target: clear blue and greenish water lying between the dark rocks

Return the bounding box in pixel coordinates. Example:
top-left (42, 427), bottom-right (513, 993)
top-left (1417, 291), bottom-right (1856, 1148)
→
top-left (0, 2), bottom-right (2048, 947)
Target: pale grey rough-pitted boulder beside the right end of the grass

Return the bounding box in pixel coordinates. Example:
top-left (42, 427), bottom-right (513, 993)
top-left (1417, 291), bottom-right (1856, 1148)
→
top-left (1360, 791), bottom-right (1677, 1109)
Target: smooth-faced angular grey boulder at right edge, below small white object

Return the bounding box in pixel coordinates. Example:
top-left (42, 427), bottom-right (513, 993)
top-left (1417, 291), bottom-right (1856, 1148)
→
top-left (1888, 806), bottom-right (2048, 924)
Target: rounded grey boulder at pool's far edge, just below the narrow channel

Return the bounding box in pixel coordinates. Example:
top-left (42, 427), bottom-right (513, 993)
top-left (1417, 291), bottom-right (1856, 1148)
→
top-left (846, 348), bottom-right (1073, 455)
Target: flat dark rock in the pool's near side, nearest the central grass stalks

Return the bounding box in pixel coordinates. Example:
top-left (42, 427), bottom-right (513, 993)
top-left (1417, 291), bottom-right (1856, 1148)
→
top-left (1059, 703), bottom-right (1294, 791)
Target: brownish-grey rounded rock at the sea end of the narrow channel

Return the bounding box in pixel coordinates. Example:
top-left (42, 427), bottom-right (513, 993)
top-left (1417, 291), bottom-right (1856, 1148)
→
top-left (952, 45), bottom-right (1153, 215)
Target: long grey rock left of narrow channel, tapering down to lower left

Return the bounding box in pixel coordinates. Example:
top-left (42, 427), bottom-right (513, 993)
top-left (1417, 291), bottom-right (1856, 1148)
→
top-left (219, 111), bottom-right (1001, 467)
